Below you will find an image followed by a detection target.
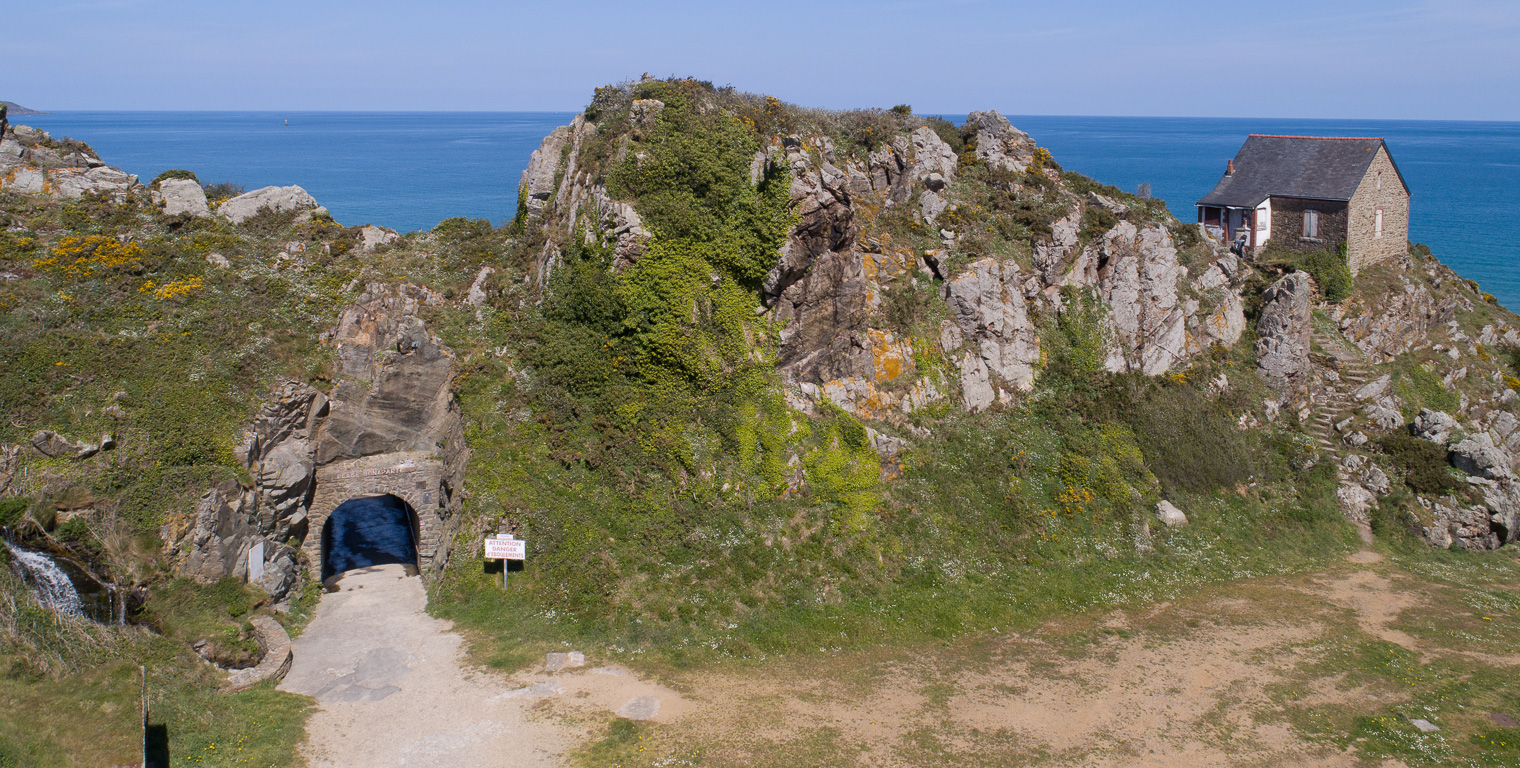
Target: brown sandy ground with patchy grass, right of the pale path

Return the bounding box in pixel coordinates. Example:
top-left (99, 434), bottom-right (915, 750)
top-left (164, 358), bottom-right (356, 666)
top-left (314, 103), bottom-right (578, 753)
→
top-left (647, 551), bottom-right (1453, 768)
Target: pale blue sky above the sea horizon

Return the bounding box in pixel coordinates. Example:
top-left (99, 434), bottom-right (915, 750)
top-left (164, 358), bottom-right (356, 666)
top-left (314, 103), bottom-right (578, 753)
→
top-left (0, 0), bottom-right (1520, 120)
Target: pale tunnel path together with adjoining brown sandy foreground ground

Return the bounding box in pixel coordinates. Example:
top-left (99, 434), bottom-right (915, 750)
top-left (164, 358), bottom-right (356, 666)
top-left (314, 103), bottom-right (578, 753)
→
top-left (281, 551), bottom-right (1520, 768)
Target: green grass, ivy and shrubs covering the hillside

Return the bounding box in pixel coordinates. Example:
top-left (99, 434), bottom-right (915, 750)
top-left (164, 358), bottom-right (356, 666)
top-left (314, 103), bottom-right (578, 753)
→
top-left (0, 79), bottom-right (1520, 765)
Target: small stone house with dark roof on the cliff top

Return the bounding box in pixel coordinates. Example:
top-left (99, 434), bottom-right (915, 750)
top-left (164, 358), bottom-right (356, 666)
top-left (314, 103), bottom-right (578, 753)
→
top-left (1198, 134), bottom-right (1409, 274)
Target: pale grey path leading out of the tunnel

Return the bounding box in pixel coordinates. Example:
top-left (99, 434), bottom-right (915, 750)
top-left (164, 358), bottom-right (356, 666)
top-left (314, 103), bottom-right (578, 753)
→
top-left (280, 566), bottom-right (684, 768)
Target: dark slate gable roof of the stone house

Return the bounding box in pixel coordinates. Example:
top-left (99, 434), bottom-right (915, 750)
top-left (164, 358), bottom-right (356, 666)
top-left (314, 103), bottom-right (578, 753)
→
top-left (1198, 134), bottom-right (1409, 208)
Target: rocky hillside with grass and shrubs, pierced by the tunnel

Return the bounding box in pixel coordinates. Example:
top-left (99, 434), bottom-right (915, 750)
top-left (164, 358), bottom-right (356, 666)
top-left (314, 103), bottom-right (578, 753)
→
top-left (0, 81), bottom-right (1520, 763)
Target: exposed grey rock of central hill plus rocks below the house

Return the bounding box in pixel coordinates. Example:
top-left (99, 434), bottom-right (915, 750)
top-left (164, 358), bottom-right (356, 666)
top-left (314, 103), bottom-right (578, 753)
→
top-left (521, 80), bottom-right (1520, 549)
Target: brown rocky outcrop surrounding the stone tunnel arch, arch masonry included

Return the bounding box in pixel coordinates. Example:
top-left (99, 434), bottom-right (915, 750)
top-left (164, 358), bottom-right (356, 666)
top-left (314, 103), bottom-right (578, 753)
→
top-left (176, 284), bottom-right (470, 590)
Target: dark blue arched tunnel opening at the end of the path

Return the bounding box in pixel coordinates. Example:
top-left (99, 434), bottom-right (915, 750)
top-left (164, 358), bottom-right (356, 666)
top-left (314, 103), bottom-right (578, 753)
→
top-left (322, 494), bottom-right (416, 586)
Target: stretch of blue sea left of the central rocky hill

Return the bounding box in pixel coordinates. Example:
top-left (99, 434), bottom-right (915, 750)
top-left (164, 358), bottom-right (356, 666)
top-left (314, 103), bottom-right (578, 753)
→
top-left (26, 113), bottom-right (575, 231)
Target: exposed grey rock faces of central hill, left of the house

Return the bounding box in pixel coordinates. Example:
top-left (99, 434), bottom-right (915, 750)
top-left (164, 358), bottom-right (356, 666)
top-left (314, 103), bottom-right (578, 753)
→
top-left (521, 99), bottom-right (1245, 423)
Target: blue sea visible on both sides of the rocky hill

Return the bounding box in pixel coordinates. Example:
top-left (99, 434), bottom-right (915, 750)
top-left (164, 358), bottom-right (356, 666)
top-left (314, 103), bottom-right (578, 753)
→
top-left (12, 111), bottom-right (1520, 310)
